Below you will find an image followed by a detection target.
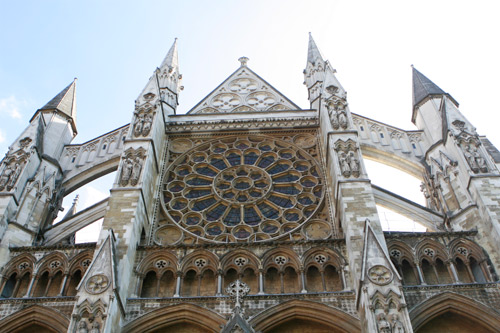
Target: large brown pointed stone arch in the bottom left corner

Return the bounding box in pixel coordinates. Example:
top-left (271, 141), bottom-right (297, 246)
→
top-left (0, 305), bottom-right (69, 333)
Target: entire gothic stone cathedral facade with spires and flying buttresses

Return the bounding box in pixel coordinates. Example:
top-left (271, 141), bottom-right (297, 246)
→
top-left (0, 37), bottom-right (500, 333)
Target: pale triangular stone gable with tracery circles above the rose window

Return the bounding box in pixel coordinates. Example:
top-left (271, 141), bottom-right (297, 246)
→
top-left (188, 58), bottom-right (301, 114)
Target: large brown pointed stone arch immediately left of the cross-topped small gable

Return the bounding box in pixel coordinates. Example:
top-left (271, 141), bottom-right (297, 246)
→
top-left (123, 303), bottom-right (226, 333)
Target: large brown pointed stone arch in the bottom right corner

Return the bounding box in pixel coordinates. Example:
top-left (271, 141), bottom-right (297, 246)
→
top-left (409, 292), bottom-right (500, 332)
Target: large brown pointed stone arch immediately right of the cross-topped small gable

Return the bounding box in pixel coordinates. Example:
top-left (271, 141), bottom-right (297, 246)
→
top-left (250, 300), bottom-right (361, 333)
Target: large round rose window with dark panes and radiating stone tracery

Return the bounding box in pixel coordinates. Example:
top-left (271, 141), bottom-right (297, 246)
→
top-left (162, 136), bottom-right (324, 242)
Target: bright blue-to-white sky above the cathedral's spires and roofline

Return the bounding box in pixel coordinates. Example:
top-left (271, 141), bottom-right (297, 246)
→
top-left (0, 0), bottom-right (500, 236)
